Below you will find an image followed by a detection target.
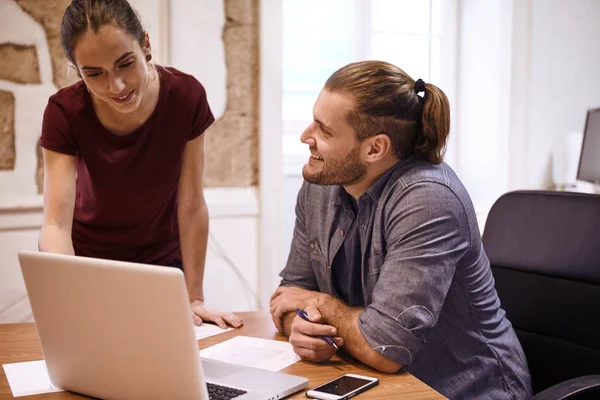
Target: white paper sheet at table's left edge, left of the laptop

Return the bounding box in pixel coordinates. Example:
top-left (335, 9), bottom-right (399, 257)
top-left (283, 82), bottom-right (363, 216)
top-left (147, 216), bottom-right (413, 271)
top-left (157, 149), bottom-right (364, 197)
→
top-left (3, 360), bottom-right (62, 397)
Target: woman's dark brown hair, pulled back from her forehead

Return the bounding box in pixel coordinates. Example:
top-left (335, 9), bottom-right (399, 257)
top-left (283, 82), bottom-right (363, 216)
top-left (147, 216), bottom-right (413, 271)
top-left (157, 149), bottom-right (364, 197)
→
top-left (60, 0), bottom-right (145, 64)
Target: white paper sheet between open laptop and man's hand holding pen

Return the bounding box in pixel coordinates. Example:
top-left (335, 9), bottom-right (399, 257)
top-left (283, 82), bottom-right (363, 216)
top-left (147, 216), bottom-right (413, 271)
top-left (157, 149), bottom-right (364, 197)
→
top-left (200, 336), bottom-right (300, 371)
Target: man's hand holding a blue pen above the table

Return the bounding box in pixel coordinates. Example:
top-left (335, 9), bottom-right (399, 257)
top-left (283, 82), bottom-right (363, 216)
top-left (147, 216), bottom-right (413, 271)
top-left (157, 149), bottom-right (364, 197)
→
top-left (289, 305), bottom-right (344, 362)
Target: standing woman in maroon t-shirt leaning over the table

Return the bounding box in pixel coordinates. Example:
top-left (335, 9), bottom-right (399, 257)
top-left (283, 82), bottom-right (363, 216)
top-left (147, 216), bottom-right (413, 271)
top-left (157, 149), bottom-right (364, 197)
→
top-left (39, 0), bottom-right (242, 327)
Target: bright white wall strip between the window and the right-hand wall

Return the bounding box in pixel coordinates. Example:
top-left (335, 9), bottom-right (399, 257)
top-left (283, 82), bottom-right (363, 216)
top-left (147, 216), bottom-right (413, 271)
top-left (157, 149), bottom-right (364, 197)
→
top-left (453, 0), bottom-right (512, 209)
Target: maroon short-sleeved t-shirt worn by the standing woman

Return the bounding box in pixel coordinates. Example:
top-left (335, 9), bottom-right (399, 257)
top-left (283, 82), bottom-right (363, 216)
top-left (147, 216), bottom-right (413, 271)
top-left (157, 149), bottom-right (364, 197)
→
top-left (41, 66), bottom-right (214, 265)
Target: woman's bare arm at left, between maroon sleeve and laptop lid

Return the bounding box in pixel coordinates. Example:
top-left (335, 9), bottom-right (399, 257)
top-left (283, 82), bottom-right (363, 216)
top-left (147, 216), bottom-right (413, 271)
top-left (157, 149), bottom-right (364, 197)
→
top-left (38, 149), bottom-right (75, 255)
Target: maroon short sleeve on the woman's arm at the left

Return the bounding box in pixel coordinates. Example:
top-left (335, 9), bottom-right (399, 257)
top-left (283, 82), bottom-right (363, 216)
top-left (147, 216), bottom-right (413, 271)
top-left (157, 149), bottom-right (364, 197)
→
top-left (40, 98), bottom-right (78, 156)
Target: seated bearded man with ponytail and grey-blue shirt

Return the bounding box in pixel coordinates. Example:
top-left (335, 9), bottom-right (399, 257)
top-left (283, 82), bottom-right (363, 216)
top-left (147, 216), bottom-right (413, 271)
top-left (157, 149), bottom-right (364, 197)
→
top-left (271, 61), bottom-right (531, 399)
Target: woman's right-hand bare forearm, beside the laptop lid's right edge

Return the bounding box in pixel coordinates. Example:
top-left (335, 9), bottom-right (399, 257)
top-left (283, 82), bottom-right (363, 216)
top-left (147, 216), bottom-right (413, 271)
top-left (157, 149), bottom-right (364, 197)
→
top-left (179, 205), bottom-right (208, 301)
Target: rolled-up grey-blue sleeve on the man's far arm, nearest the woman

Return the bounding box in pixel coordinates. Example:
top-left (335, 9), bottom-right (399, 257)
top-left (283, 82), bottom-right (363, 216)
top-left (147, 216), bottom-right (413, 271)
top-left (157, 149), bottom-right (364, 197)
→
top-left (279, 182), bottom-right (319, 291)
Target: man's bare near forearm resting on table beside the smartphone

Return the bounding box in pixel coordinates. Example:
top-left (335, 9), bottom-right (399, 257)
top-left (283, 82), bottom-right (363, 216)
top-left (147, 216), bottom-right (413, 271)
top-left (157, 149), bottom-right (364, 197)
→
top-left (318, 295), bottom-right (402, 373)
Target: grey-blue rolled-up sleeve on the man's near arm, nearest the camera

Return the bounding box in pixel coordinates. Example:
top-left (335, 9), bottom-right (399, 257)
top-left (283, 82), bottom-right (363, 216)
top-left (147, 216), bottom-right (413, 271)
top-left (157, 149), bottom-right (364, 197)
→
top-left (358, 182), bottom-right (471, 365)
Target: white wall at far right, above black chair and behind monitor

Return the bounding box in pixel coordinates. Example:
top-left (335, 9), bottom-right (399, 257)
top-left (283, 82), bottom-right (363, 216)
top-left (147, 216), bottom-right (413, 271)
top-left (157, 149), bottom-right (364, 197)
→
top-left (523, 0), bottom-right (600, 187)
